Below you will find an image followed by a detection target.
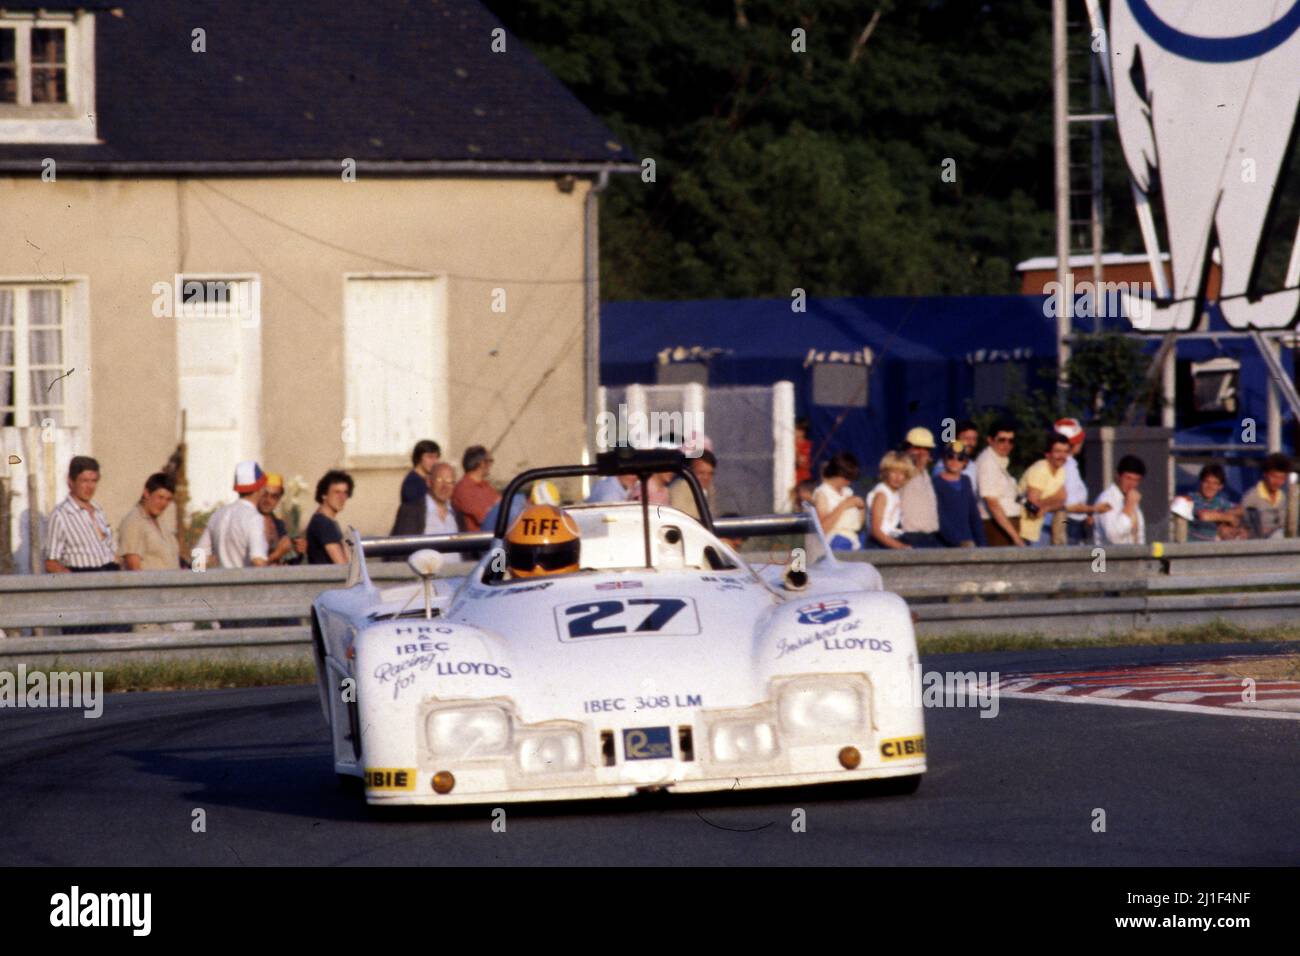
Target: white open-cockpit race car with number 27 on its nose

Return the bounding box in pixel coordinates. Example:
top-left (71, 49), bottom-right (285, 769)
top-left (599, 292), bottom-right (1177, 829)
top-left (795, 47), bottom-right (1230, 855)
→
top-left (312, 451), bottom-right (926, 805)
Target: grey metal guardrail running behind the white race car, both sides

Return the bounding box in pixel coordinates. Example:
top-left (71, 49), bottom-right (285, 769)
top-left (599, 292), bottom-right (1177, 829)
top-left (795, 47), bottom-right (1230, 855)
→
top-left (0, 538), bottom-right (1300, 669)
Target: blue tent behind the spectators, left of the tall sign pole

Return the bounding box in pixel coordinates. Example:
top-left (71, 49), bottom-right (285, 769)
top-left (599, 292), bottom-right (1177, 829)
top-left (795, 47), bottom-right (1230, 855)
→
top-left (601, 295), bottom-right (1056, 475)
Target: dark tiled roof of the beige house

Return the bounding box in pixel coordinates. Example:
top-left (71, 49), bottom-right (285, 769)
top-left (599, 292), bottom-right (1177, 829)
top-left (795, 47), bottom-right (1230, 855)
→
top-left (0, 0), bottom-right (633, 170)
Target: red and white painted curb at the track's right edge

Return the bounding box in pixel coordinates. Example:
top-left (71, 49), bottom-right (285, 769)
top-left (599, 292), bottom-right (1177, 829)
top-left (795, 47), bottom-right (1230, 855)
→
top-left (997, 657), bottom-right (1300, 721)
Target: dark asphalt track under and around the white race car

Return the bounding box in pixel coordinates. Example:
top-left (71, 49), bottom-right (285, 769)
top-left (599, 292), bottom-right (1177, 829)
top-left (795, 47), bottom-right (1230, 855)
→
top-left (0, 645), bottom-right (1300, 866)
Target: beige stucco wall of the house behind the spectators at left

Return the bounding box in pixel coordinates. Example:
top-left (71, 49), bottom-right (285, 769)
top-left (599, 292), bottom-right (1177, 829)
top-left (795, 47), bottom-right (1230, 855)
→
top-left (0, 176), bottom-right (588, 533)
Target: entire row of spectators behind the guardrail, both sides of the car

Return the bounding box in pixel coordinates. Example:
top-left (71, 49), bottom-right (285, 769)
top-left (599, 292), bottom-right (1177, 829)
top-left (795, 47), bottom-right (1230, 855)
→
top-left (27, 418), bottom-right (1292, 574)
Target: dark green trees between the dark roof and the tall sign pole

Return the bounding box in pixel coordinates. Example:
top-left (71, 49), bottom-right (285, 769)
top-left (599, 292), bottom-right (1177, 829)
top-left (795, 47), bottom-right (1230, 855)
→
top-left (488, 0), bottom-right (1052, 299)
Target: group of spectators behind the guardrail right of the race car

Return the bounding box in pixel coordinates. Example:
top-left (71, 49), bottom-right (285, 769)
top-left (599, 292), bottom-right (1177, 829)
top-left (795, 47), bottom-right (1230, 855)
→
top-left (794, 418), bottom-right (1292, 550)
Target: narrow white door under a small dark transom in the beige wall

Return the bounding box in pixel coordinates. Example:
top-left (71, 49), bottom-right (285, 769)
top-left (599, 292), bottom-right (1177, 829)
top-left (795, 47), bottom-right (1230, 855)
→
top-left (177, 281), bottom-right (261, 510)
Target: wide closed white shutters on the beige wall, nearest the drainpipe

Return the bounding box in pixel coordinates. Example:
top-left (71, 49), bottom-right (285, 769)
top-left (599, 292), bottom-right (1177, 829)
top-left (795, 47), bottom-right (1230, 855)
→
top-left (343, 277), bottom-right (450, 459)
